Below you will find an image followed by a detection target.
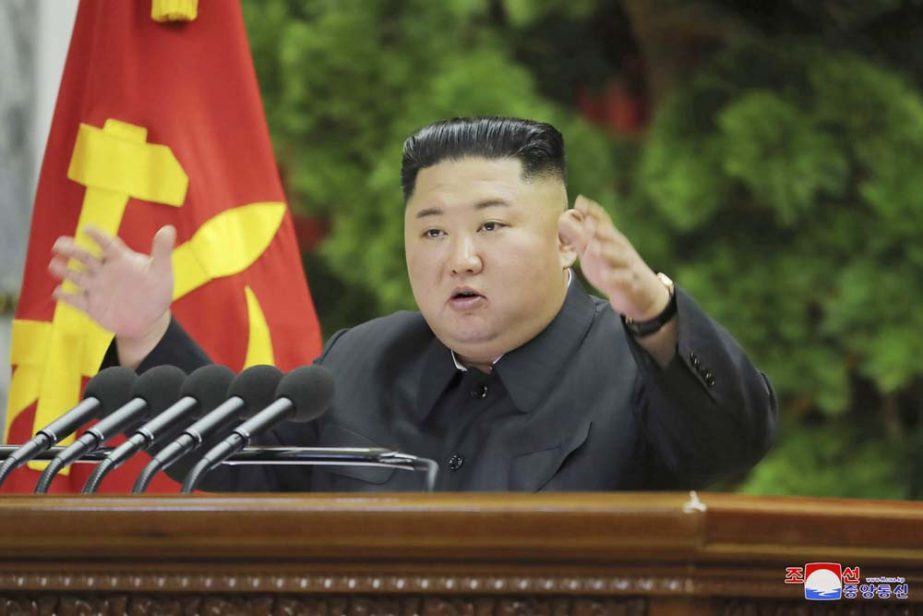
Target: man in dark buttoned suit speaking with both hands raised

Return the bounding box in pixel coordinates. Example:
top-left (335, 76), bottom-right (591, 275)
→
top-left (50, 118), bottom-right (776, 491)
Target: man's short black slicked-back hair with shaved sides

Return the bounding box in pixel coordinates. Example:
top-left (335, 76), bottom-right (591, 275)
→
top-left (401, 117), bottom-right (567, 203)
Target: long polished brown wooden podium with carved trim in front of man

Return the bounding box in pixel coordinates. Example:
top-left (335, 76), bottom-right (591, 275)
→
top-left (0, 493), bottom-right (923, 616)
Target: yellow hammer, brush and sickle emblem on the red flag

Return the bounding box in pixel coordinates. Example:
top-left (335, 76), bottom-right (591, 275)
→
top-left (4, 119), bottom-right (285, 467)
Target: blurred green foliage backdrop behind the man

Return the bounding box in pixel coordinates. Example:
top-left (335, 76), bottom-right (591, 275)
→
top-left (236, 0), bottom-right (923, 498)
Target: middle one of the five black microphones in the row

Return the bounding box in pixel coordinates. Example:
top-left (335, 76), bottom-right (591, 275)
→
top-left (83, 364), bottom-right (234, 494)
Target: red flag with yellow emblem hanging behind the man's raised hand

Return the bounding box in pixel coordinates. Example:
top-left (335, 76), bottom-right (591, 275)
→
top-left (4, 0), bottom-right (321, 491)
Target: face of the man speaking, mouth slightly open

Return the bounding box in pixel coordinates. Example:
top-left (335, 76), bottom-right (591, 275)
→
top-left (404, 158), bottom-right (575, 365)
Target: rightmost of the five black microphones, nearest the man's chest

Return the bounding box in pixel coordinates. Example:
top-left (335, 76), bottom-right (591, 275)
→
top-left (182, 366), bottom-right (333, 493)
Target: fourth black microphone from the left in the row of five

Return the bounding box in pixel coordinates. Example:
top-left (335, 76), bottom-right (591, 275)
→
top-left (131, 365), bottom-right (282, 493)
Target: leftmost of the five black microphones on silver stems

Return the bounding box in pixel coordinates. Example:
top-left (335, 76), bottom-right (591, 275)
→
top-left (0, 366), bottom-right (138, 485)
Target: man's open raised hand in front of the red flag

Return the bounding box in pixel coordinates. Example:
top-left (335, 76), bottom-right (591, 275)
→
top-left (48, 226), bottom-right (176, 342)
